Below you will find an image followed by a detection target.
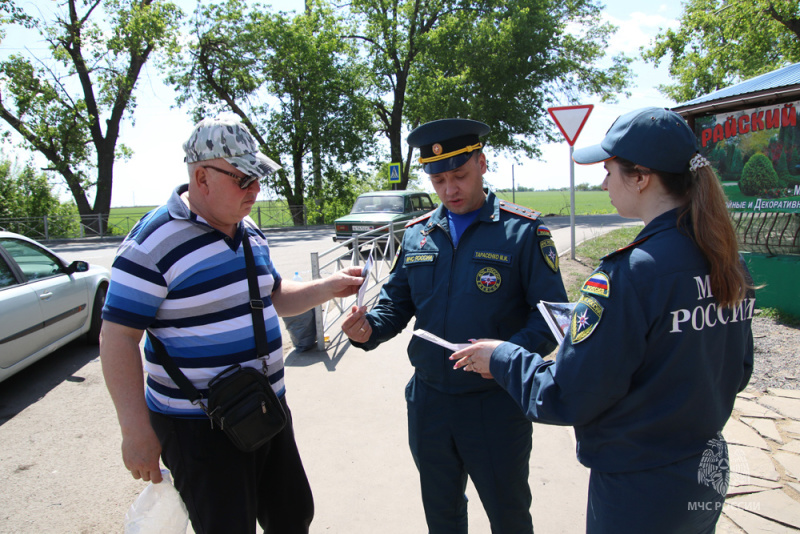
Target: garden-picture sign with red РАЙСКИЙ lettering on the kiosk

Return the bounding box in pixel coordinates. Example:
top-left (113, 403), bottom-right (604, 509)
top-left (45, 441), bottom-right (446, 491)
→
top-left (695, 102), bottom-right (800, 213)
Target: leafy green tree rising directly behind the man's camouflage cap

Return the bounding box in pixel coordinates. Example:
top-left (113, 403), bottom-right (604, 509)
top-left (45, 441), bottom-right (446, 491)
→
top-left (168, 0), bottom-right (374, 224)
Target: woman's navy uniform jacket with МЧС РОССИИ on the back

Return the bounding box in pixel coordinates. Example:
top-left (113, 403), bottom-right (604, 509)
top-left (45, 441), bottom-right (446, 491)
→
top-left (490, 210), bottom-right (755, 472)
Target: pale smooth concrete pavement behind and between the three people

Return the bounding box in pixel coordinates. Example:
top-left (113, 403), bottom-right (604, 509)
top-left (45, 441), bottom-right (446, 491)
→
top-left (274, 217), bottom-right (635, 534)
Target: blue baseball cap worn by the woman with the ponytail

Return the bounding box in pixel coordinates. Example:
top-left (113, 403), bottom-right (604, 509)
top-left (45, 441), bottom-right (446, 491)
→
top-left (572, 107), bottom-right (698, 174)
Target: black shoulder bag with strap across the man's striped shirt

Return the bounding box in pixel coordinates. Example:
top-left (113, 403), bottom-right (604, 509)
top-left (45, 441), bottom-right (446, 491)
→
top-left (150, 231), bottom-right (287, 452)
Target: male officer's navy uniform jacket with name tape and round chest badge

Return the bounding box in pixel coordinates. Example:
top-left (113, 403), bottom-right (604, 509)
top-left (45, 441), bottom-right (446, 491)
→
top-left (354, 193), bottom-right (566, 393)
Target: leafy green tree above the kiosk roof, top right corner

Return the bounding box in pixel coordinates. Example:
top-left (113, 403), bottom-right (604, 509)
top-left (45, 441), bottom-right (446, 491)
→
top-left (642, 0), bottom-right (800, 102)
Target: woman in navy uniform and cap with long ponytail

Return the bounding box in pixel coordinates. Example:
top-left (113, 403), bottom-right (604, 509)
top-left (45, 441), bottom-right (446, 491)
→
top-left (452, 108), bottom-right (755, 533)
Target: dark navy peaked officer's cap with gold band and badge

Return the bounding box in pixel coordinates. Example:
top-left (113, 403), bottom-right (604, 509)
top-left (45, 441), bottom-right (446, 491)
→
top-left (407, 119), bottom-right (491, 174)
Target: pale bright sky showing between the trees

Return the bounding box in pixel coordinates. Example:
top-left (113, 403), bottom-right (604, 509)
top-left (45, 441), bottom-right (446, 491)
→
top-left (0, 0), bottom-right (681, 206)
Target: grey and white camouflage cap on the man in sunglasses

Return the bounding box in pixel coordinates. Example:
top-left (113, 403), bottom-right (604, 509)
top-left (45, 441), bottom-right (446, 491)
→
top-left (183, 116), bottom-right (281, 179)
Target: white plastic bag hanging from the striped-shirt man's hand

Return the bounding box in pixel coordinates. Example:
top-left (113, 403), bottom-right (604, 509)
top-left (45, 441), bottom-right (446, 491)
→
top-left (125, 469), bottom-right (189, 534)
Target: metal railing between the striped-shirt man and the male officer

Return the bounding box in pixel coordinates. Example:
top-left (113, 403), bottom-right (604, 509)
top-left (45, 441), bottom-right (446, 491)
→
top-left (311, 223), bottom-right (404, 350)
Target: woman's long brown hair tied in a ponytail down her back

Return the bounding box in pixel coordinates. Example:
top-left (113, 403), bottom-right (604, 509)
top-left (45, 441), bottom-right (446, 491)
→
top-left (616, 158), bottom-right (751, 307)
